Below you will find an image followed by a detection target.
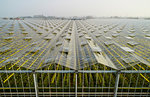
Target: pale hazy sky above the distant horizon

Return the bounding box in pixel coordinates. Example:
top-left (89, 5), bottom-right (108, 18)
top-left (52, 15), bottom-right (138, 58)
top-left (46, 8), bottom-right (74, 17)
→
top-left (0, 0), bottom-right (150, 17)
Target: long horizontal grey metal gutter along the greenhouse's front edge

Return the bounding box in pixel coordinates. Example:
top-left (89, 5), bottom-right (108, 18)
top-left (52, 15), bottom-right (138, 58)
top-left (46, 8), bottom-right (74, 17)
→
top-left (0, 70), bottom-right (150, 73)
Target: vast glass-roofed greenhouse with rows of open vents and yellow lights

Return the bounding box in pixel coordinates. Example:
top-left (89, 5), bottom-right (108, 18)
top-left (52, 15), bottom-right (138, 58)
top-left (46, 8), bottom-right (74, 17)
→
top-left (0, 18), bottom-right (150, 97)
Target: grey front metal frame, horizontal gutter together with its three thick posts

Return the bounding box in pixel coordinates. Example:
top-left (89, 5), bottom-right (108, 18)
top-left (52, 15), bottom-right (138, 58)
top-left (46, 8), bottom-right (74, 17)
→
top-left (0, 70), bottom-right (150, 97)
